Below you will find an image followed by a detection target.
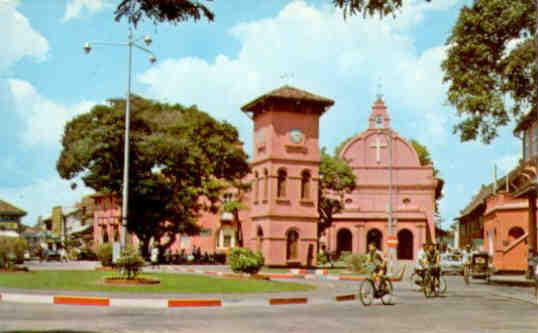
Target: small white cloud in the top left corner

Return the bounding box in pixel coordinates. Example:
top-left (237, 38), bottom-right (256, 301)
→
top-left (0, 0), bottom-right (49, 72)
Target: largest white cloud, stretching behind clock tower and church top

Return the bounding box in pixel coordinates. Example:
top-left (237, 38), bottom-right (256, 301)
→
top-left (139, 0), bottom-right (456, 152)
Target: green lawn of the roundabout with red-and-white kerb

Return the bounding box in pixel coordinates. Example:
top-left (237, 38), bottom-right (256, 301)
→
top-left (0, 271), bottom-right (314, 293)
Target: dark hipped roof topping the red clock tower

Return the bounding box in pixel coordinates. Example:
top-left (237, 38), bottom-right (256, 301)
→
top-left (241, 85), bottom-right (334, 112)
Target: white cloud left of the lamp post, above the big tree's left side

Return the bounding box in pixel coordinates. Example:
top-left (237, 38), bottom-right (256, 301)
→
top-left (8, 79), bottom-right (95, 146)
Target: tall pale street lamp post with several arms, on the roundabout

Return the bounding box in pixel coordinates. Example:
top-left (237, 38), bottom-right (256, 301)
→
top-left (83, 24), bottom-right (157, 249)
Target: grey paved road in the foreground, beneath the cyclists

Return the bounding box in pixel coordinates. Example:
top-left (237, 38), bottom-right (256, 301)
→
top-left (0, 277), bottom-right (538, 333)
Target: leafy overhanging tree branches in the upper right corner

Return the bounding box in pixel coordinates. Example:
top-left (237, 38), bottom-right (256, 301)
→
top-left (442, 0), bottom-right (538, 143)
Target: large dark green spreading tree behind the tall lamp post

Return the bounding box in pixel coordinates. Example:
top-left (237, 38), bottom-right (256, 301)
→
top-left (57, 96), bottom-right (249, 256)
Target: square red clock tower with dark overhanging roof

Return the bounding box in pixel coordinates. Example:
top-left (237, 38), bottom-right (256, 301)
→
top-left (241, 86), bottom-right (334, 266)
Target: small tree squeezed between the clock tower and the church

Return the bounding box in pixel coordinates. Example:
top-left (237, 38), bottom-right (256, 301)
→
top-left (318, 149), bottom-right (357, 234)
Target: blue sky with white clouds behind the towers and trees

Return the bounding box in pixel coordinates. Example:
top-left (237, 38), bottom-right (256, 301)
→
top-left (0, 0), bottom-right (521, 227)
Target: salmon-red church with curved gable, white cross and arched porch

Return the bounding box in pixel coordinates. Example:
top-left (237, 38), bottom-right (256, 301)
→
top-left (325, 98), bottom-right (442, 260)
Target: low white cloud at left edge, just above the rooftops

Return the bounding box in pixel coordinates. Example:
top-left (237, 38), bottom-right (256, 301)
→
top-left (0, 176), bottom-right (93, 225)
